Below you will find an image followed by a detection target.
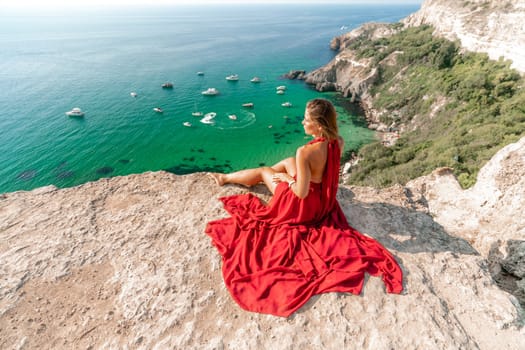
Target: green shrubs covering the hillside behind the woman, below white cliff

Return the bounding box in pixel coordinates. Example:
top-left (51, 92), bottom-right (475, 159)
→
top-left (349, 26), bottom-right (525, 188)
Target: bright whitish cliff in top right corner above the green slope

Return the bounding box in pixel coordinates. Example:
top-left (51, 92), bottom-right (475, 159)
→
top-left (403, 0), bottom-right (525, 72)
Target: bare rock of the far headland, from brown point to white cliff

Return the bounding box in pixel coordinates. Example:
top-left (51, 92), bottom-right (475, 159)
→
top-left (301, 0), bottom-right (525, 129)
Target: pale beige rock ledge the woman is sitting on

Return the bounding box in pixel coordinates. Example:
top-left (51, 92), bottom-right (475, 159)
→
top-left (0, 139), bottom-right (525, 350)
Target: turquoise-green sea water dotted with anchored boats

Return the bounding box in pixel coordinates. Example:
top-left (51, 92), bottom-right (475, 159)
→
top-left (0, 5), bottom-right (419, 193)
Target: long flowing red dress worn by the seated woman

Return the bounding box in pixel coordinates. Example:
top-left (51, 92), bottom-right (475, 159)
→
top-left (206, 139), bottom-right (403, 317)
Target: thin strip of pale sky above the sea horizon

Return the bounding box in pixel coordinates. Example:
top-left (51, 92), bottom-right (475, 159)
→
top-left (0, 0), bottom-right (423, 11)
